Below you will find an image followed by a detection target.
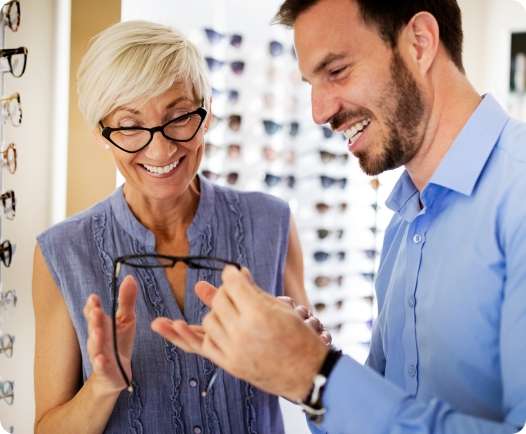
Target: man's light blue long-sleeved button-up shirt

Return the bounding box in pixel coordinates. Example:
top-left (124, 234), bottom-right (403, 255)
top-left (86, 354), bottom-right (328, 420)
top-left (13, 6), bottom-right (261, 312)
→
top-left (313, 95), bottom-right (526, 434)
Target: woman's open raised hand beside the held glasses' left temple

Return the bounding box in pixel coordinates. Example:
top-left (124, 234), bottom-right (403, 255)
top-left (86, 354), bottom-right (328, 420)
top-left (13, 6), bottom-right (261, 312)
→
top-left (84, 275), bottom-right (137, 394)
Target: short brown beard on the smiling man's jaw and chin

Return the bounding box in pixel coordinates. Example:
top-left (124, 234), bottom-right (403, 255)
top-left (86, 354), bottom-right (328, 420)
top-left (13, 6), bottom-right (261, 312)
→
top-left (355, 50), bottom-right (425, 176)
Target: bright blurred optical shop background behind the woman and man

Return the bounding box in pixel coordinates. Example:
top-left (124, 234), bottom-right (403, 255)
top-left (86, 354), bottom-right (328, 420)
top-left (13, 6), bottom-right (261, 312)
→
top-left (0, 0), bottom-right (526, 434)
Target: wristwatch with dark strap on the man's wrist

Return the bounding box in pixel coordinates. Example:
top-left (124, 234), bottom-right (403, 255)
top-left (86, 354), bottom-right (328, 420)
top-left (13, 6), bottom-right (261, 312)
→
top-left (298, 347), bottom-right (342, 424)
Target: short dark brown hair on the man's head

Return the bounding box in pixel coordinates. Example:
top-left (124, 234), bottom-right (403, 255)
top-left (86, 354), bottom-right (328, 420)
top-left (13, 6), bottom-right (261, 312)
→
top-left (274, 0), bottom-right (464, 72)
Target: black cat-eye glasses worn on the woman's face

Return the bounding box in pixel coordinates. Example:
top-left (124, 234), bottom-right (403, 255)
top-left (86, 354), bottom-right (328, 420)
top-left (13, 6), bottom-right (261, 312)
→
top-left (99, 107), bottom-right (207, 154)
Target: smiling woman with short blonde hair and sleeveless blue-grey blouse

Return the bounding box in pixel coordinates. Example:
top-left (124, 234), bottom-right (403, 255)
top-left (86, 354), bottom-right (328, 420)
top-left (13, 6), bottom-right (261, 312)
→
top-left (33, 22), bottom-right (322, 434)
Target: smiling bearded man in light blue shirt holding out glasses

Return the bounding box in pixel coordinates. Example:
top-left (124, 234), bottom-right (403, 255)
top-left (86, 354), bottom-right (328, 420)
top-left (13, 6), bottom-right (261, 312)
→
top-left (152, 0), bottom-right (526, 434)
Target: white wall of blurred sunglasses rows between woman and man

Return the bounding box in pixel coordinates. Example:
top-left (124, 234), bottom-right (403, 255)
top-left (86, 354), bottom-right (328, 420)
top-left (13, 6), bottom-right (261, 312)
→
top-left (193, 27), bottom-right (404, 361)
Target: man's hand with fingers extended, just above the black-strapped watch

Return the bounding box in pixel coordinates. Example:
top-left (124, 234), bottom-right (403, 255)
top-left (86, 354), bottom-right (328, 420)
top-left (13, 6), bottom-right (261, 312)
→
top-left (152, 267), bottom-right (328, 400)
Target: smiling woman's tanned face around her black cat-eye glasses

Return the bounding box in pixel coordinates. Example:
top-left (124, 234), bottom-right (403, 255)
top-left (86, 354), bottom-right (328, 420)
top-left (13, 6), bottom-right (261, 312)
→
top-left (99, 83), bottom-right (211, 200)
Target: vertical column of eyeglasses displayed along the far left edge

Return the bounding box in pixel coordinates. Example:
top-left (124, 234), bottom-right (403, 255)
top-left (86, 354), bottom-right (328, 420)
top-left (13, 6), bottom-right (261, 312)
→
top-left (0, 0), bottom-right (28, 433)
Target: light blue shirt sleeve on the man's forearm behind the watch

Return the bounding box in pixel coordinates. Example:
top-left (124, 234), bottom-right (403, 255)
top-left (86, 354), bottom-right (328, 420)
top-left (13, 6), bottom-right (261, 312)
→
top-left (313, 356), bottom-right (519, 434)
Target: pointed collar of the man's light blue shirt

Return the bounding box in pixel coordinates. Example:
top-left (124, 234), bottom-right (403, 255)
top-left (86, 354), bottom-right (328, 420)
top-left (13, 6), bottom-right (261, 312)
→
top-left (386, 95), bottom-right (509, 212)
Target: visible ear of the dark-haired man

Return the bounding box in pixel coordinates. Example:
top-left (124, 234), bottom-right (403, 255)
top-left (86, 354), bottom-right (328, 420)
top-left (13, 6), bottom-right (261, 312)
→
top-left (398, 12), bottom-right (440, 75)
